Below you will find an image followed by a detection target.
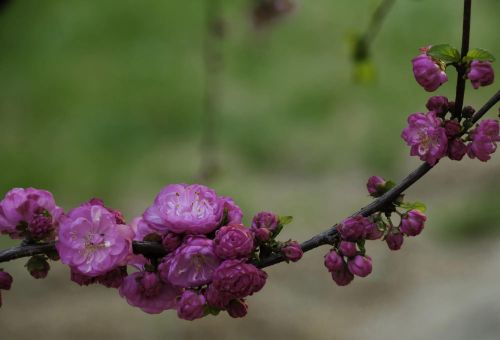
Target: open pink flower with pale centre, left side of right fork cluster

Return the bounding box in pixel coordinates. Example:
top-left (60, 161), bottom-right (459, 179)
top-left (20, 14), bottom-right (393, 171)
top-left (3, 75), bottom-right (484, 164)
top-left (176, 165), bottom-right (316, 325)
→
top-left (401, 111), bottom-right (448, 165)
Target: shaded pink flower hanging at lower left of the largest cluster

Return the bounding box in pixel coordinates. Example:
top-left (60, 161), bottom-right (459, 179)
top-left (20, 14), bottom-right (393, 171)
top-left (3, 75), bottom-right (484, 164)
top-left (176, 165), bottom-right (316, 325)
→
top-left (119, 272), bottom-right (179, 314)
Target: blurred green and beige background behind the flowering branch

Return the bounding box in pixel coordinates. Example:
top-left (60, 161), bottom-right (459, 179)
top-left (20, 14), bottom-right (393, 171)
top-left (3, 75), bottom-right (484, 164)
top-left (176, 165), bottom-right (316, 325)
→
top-left (0, 0), bottom-right (500, 340)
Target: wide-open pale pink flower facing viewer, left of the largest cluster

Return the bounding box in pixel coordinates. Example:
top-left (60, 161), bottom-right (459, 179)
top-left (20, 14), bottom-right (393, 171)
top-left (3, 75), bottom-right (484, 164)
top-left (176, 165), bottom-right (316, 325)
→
top-left (56, 204), bottom-right (134, 276)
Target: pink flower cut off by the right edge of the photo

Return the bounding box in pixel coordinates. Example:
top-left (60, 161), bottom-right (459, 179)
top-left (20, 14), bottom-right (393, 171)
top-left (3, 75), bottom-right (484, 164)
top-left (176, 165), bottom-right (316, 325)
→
top-left (467, 119), bottom-right (500, 162)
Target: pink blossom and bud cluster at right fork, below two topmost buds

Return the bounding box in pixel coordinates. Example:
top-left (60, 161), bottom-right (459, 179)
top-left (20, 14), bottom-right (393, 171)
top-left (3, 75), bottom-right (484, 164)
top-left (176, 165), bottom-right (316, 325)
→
top-left (402, 96), bottom-right (500, 165)
